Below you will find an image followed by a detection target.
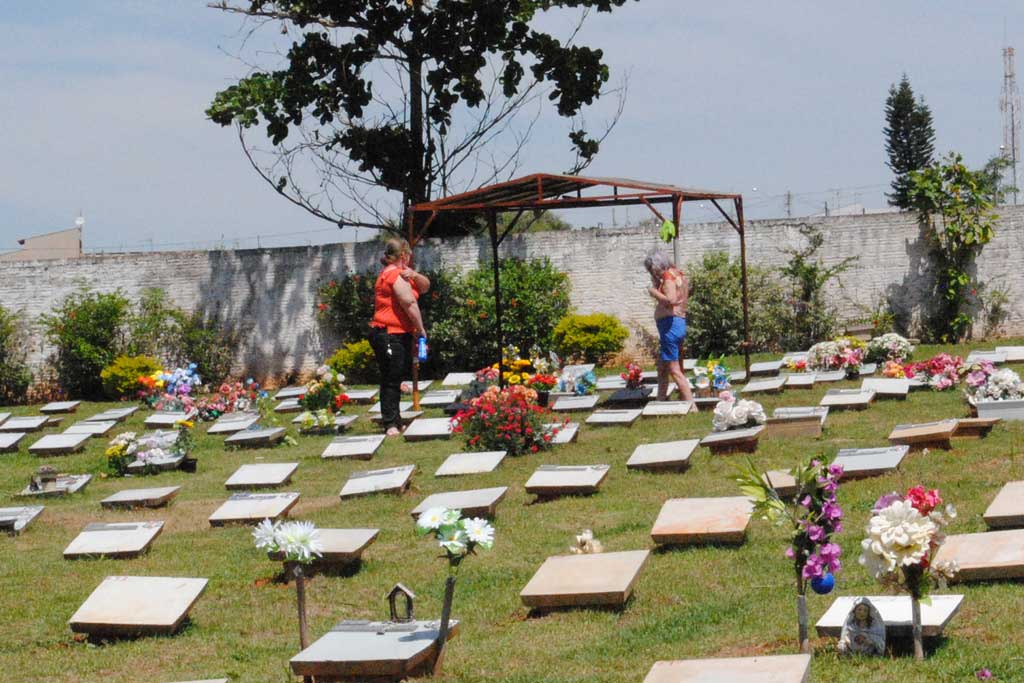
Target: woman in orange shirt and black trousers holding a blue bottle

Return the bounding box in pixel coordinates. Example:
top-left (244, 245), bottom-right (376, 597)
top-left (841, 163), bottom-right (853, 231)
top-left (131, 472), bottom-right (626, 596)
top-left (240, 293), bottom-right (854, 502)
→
top-left (370, 239), bottom-right (430, 436)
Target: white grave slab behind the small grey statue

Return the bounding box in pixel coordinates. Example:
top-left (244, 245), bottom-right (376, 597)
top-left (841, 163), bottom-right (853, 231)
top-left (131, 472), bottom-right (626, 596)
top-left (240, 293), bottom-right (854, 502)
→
top-left (815, 594), bottom-right (964, 638)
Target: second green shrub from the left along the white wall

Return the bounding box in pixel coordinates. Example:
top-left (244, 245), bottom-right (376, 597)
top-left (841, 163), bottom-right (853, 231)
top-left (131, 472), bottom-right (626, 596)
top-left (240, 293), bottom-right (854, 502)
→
top-left (40, 289), bottom-right (131, 398)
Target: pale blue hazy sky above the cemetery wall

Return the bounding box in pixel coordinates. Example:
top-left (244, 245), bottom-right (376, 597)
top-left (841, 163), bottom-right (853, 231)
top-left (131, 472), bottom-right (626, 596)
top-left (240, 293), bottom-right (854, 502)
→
top-left (0, 0), bottom-right (1024, 251)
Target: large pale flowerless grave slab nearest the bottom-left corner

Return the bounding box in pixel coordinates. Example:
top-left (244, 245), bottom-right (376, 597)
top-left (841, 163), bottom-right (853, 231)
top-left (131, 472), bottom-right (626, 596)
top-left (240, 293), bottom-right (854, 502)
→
top-left (68, 577), bottom-right (207, 638)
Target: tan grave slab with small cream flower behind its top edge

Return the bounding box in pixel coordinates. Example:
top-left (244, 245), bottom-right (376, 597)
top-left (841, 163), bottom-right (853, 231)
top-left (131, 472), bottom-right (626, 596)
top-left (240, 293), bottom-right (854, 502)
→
top-left (519, 550), bottom-right (650, 609)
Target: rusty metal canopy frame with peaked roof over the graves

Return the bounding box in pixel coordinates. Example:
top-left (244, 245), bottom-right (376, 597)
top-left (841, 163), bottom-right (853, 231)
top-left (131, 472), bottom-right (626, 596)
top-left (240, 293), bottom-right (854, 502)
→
top-left (407, 173), bottom-right (751, 389)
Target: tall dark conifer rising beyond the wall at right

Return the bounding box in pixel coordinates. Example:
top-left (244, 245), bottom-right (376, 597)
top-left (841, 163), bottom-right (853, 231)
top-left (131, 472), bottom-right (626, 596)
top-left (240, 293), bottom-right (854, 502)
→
top-left (883, 74), bottom-right (935, 209)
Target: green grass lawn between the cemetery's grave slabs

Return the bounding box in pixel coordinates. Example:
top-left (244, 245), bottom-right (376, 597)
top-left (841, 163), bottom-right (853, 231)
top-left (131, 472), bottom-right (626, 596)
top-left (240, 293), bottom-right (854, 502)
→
top-left (0, 341), bottom-right (1024, 683)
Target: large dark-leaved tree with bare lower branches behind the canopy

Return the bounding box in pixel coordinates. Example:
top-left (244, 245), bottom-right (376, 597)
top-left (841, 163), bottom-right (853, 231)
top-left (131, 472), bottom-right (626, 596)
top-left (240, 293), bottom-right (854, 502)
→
top-left (207, 0), bottom-right (627, 234)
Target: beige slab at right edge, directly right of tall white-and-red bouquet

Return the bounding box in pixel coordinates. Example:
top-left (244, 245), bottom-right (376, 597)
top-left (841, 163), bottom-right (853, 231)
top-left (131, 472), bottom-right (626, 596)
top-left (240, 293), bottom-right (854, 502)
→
top-left (935, 528), bottom-right (1024, 583)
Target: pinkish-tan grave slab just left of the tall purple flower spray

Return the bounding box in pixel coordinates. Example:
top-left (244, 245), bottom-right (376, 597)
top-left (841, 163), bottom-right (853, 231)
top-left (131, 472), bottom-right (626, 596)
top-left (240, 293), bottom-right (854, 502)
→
top-left (650, 496), bottom-right (754, 546)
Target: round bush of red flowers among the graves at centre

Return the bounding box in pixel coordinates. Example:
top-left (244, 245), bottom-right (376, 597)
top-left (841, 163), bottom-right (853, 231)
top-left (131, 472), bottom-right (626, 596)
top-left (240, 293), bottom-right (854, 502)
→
top-left (453, 385), bottom-right (554, 456)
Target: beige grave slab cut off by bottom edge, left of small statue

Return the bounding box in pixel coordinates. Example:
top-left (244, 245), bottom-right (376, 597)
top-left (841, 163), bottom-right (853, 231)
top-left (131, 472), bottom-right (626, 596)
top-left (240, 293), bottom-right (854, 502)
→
top-left (644, 654), bottom-right (811, 683)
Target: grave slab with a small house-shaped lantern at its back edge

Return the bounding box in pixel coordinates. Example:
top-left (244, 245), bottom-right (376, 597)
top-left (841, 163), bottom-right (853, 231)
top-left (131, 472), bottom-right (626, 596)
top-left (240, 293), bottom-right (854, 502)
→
top-left (290, 620), bottom-right (459, 683)
